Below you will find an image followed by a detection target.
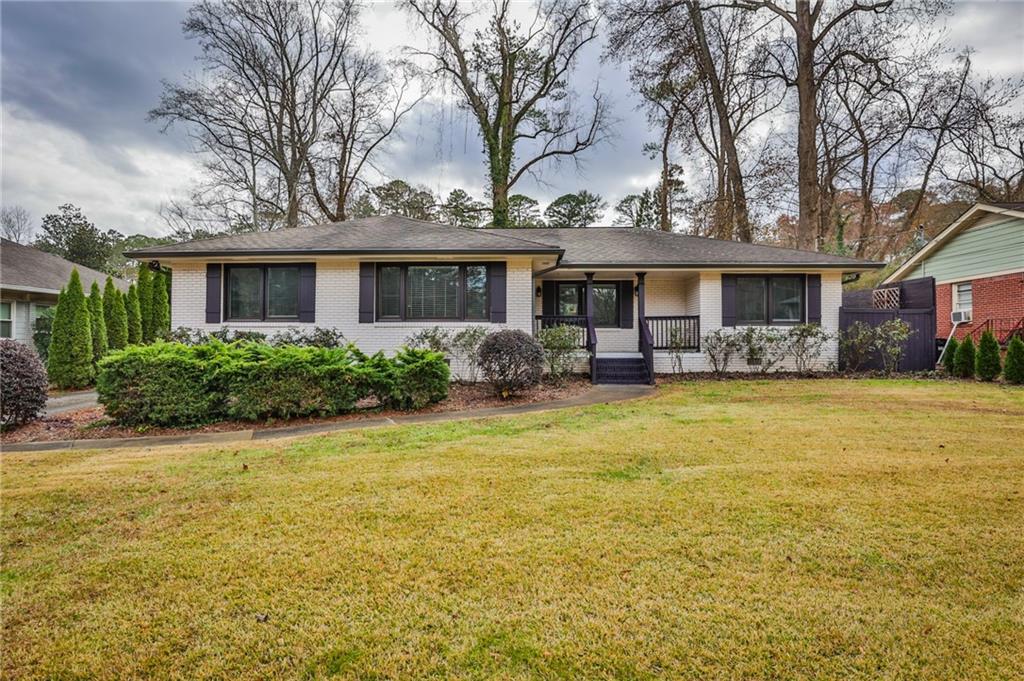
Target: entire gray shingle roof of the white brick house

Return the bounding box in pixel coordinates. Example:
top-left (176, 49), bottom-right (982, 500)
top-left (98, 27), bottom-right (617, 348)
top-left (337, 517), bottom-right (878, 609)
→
top-left (127, 215), bottom-right (883, 269)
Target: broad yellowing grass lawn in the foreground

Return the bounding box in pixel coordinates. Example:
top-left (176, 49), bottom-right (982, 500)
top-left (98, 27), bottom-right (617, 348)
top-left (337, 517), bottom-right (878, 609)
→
top-left (0, 380), bottom-right (1024, 679)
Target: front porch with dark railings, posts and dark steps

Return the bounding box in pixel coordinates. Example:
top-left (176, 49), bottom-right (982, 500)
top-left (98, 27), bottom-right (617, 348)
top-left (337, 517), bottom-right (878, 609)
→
top-left (534, 271), bottom-right (700, 384)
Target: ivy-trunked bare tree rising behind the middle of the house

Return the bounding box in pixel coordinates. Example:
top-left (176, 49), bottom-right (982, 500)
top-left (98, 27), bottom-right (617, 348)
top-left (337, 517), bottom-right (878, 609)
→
top-left (404, 0), bottom-right (607, 227)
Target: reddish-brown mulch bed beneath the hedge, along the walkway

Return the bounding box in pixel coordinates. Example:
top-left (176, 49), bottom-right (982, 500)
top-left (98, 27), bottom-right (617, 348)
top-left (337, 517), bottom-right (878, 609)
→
top-left (0, 377), bottom-right (591, 444)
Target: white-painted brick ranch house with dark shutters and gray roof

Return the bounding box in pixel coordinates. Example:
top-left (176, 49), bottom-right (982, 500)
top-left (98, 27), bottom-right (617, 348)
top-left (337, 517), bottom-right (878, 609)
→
top-left (127, 216), bottom-right (882, 382)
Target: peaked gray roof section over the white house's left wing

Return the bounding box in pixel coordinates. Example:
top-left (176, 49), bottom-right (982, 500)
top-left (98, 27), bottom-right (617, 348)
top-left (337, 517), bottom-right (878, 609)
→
top-left (128, 215), bottom-right (559, 258)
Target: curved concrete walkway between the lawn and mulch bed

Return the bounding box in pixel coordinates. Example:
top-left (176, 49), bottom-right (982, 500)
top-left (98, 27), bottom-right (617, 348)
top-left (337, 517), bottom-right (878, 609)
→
top-left (3, 385), bottom-right (654, 452)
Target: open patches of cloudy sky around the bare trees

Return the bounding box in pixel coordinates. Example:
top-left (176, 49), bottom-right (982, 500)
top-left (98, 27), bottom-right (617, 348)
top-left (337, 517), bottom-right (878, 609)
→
top-left (0, 0), bottom-right (1024, 235)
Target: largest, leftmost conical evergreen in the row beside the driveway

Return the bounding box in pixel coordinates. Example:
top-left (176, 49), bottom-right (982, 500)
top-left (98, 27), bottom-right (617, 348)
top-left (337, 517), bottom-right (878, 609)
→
top-left (46, 268), bottom-right (95, 388)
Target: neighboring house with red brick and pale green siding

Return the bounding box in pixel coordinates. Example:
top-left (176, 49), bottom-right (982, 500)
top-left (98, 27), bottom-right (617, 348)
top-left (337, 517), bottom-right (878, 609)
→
top-left (883, 203), bottom-right (1024, 342)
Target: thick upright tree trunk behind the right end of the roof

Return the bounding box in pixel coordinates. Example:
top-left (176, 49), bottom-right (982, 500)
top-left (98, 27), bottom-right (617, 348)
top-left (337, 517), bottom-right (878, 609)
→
top-left (796, 0), bottom-right (821, 249)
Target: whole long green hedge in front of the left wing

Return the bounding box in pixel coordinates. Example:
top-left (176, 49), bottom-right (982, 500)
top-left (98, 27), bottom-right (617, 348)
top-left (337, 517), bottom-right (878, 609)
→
top-left (96, 340), bottom-right (449, 427)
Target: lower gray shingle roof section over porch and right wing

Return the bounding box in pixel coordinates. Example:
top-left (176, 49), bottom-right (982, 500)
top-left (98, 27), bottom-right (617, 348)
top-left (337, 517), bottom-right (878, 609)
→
top-left (482, 227), bottom-right (884, 268)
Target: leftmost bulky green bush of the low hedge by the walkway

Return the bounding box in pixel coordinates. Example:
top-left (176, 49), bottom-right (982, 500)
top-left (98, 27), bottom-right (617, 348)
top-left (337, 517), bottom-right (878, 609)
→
top-left (96, 343), bottom-right (227, 426)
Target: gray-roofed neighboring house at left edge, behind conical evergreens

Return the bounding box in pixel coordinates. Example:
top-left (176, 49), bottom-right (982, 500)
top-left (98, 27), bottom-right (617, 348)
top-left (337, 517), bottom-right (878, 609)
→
top-left (0, 239), bottom-right (128, 344)
